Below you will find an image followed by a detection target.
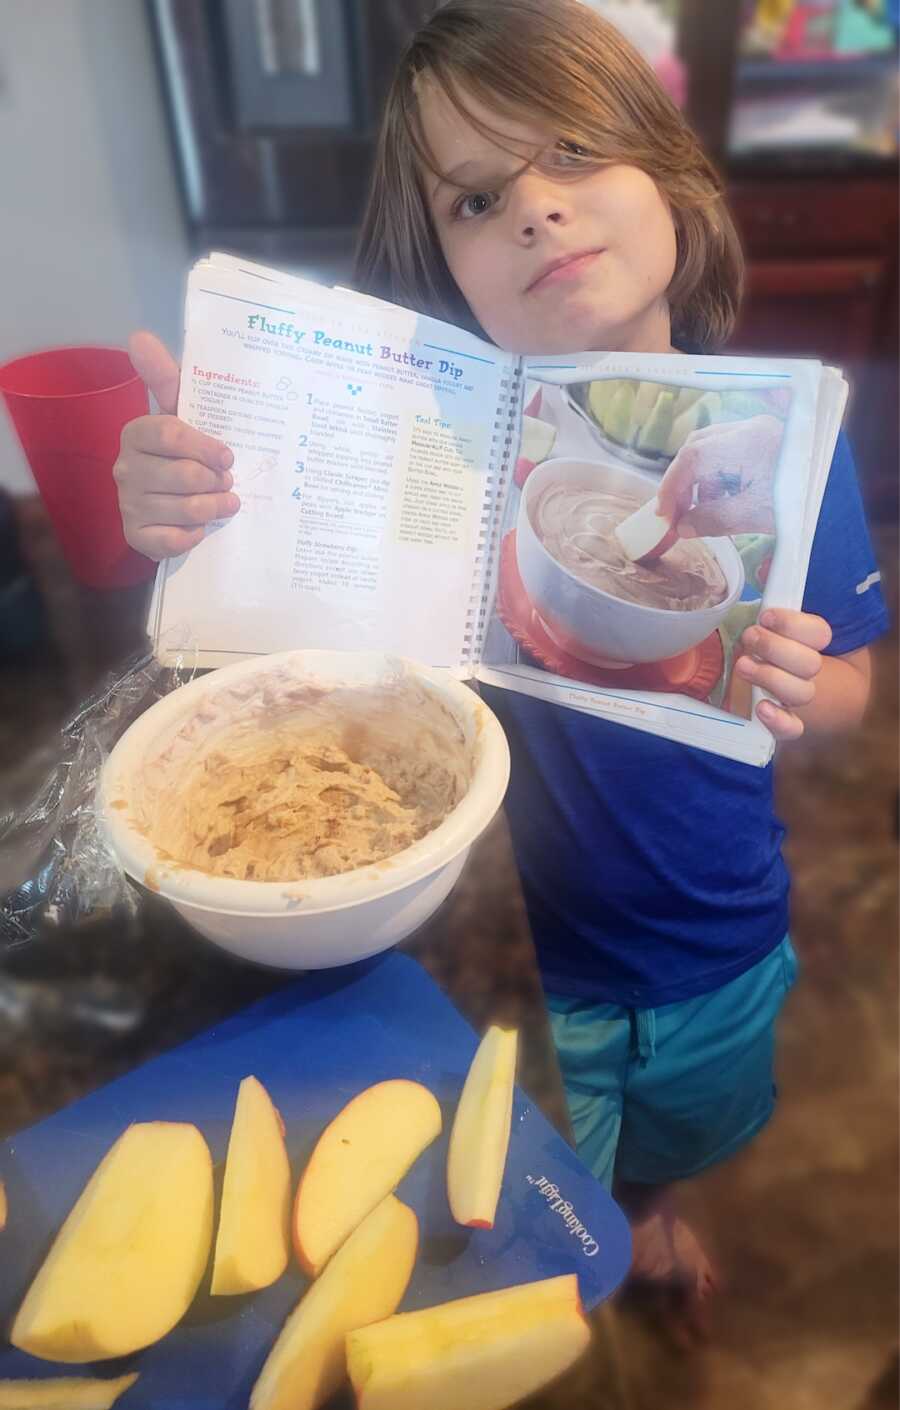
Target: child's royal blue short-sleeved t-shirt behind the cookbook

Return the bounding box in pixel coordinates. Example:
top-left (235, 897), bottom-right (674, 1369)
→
top-left (482, 436), bottom-right (887, 1008)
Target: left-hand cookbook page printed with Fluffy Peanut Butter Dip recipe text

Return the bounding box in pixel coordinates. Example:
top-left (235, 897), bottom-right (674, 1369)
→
top-left (151, 257), bottom-right (516, 668)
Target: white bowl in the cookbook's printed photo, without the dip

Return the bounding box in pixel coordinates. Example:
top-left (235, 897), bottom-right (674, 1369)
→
top-left (516, 460), bottom-right (743, 666)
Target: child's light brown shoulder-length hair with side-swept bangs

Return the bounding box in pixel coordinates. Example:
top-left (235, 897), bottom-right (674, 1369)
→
top-left (355, 0), bottom-right (743, 350)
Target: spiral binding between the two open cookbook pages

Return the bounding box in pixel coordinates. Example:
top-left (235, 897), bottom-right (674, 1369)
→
top-left (460, 364), bottom-right (525, 671)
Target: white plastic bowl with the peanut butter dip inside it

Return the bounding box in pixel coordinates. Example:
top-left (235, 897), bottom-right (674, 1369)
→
top-left (99, 651), bottom-right (509, 969)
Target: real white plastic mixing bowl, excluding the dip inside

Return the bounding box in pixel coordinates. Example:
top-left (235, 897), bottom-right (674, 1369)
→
top-left (99, 651), bottom-right (509, 969)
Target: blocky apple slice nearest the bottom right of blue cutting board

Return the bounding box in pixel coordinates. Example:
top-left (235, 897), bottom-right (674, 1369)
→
top-left (347, 1273), bottom-right (591, 1410)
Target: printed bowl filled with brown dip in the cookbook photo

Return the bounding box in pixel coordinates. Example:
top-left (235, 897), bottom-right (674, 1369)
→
top-left (516, 458), bottom-right (743, 667)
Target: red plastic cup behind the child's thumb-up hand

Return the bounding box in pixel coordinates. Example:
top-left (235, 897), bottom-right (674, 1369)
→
top-left (0, 348), bottom-right (157, 588)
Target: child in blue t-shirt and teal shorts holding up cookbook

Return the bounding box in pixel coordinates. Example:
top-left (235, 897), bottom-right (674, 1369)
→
top-left (116, 0), bottom-right (884, 1336)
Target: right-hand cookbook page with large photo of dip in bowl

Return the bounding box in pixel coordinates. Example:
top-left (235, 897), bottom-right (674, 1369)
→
top-left (478, 354), bottom-right (846, 764)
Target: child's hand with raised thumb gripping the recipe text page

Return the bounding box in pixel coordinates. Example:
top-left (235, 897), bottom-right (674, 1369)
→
top-left (113, 333), bottom-right (241, 560)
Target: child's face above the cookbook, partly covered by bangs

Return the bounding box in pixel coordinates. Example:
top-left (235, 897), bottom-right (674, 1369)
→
top-left (419, 82), bottom-right (676, 353)
